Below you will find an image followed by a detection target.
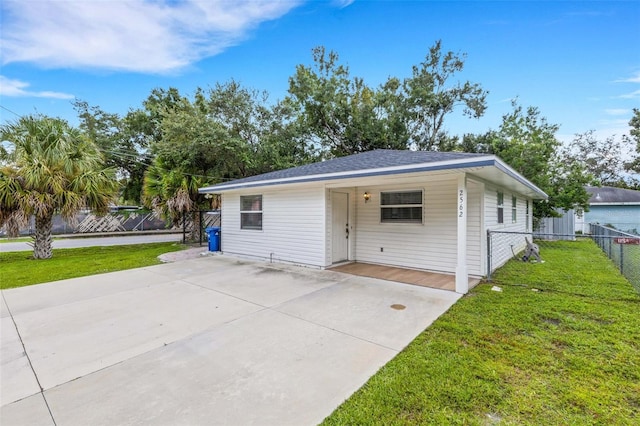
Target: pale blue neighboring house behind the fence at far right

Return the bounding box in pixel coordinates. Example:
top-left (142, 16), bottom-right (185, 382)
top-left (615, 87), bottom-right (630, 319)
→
top-left (575, 186), bottom-right (640, 234)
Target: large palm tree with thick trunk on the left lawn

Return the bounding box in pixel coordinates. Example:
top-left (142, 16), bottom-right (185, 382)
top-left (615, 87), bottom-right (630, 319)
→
top-left (0, 115), bottom-right (117, 259)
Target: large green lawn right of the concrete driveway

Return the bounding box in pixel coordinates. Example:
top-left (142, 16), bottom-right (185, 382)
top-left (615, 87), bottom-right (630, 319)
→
top-left (324, 241), bottom-right (640, 425)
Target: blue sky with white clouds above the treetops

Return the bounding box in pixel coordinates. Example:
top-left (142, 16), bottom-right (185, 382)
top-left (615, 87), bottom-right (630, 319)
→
top-left (0, 0), bottom-right (640, 144)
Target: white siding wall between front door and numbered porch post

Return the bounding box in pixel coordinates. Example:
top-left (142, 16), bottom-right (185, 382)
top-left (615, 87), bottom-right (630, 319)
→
top-left (355, 175), bottom-right (457, 273)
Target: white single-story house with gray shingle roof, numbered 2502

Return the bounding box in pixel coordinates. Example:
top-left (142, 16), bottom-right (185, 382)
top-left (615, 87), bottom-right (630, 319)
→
top-left (200, 150), bottom-right (546, 293)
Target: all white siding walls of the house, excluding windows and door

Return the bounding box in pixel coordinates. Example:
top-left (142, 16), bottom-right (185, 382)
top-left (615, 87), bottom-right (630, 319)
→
top-left (221, 173), bottom-right (533, 276)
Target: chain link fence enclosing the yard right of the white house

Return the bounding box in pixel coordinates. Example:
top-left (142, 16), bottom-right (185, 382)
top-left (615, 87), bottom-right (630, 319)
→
top-left (487, 228), bottom-right (640, 292)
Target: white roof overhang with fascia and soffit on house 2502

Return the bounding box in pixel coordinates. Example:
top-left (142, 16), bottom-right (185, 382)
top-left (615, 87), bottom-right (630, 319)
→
top-left (199, 155), bottom-right (547, 199)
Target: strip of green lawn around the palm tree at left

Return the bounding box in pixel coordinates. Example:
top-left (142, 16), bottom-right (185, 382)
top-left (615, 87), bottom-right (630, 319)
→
top-left (0, 243), bottom-right (184, 290)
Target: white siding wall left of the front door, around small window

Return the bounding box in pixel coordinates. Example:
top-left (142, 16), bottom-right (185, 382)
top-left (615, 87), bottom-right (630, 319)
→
top-left (221, 186), bottom-right (326, 267)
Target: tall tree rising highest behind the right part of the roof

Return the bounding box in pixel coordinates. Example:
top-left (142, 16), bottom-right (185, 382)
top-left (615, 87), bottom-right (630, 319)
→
top-left (403, 40), bottom-right (488, 151)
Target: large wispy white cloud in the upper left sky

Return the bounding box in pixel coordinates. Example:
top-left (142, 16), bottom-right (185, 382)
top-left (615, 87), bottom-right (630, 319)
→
top-left (0, 0), bottom-right (301, 73)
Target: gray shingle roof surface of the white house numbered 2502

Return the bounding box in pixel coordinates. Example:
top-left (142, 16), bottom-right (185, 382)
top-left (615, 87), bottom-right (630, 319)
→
top-left (203, 149), bottom-right (486, 190)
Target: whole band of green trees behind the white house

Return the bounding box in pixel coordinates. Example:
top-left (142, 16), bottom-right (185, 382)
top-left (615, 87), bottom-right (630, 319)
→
top-left (52, 40), bottom-right (640, 226)
